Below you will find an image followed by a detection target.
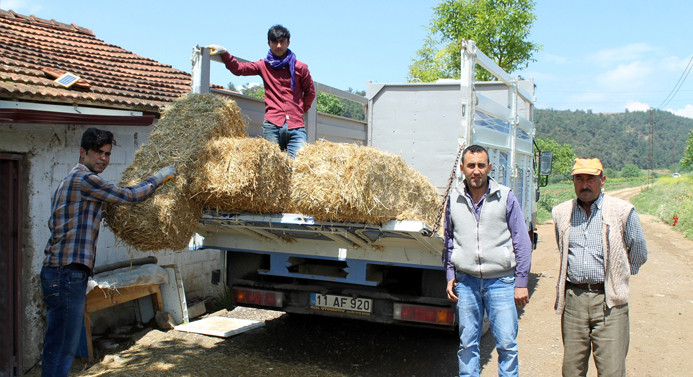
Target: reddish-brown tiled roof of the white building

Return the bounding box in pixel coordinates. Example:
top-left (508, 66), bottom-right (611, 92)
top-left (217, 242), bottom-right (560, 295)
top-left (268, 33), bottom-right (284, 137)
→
top-left (0, 10), bottom-right (191, 113)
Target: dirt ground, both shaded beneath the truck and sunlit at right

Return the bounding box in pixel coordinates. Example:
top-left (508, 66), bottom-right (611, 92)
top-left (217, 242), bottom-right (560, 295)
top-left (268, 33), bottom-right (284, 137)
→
top-left (29, 189), bottom-right (693, 377)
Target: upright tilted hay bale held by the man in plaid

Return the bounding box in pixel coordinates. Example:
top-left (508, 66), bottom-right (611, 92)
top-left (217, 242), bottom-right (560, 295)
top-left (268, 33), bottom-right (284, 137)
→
top-left (104, 94), bottom-right (247, 250)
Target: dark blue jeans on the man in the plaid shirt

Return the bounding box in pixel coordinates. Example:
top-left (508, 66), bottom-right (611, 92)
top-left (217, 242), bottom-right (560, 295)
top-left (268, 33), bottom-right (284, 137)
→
top-left (41, 266), bottom-right (89, 377)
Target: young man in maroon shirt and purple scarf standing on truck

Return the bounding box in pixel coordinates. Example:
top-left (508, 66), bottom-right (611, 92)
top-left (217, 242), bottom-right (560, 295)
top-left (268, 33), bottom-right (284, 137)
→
top-left (207, 25), bottom-right (315, 157)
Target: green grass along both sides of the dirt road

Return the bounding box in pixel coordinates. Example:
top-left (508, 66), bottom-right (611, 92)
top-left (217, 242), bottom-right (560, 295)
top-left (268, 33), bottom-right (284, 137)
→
top-left (537, 175), bottom-right (693, 239)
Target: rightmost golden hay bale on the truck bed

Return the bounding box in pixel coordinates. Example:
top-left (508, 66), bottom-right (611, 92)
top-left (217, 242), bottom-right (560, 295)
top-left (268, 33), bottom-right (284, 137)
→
top-left (291, 140), bottom-right (439, 224)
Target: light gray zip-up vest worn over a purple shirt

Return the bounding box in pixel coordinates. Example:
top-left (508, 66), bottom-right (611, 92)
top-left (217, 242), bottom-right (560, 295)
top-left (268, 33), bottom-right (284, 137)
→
top-left (450, 178), bottom-right (516, 279)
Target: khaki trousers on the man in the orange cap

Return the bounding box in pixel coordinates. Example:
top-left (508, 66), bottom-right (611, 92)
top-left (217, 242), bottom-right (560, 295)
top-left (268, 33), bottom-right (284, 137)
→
top-left (561, 287), bottom-right (630, 377)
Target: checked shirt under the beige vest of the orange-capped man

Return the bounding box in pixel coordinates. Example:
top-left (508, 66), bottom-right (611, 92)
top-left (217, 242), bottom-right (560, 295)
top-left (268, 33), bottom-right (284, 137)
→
top-left (568, 194), bottom-right (647, 284)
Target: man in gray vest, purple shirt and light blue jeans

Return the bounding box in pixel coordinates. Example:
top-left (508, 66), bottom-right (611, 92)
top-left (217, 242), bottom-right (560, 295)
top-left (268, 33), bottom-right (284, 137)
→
top-left (443, 145), bottom-right (532, 376)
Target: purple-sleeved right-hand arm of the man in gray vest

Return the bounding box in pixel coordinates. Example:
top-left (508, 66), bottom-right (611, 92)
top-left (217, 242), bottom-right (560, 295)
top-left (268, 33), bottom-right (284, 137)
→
top-left (506, 191), bottom-right (532, 306)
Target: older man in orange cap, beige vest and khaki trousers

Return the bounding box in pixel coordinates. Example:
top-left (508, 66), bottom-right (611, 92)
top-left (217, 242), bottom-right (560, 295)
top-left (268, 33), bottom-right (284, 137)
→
top-left (552, 158), bottom-right (647, 377)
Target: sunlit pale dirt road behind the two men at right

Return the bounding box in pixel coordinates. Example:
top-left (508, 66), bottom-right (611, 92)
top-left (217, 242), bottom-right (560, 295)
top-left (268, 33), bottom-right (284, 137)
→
top-left (482, 188), bottom-right (693, 377)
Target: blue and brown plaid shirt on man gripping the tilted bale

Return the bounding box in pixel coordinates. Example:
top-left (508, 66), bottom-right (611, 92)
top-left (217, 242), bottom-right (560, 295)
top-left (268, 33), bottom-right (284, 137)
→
top-left (43, 164), bottom-right (159, 269)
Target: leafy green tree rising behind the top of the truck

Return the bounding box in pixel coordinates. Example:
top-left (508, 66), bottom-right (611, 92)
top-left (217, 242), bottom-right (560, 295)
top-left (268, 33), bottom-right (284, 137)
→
top-left (409, 0), bottom-right (541, 82)
